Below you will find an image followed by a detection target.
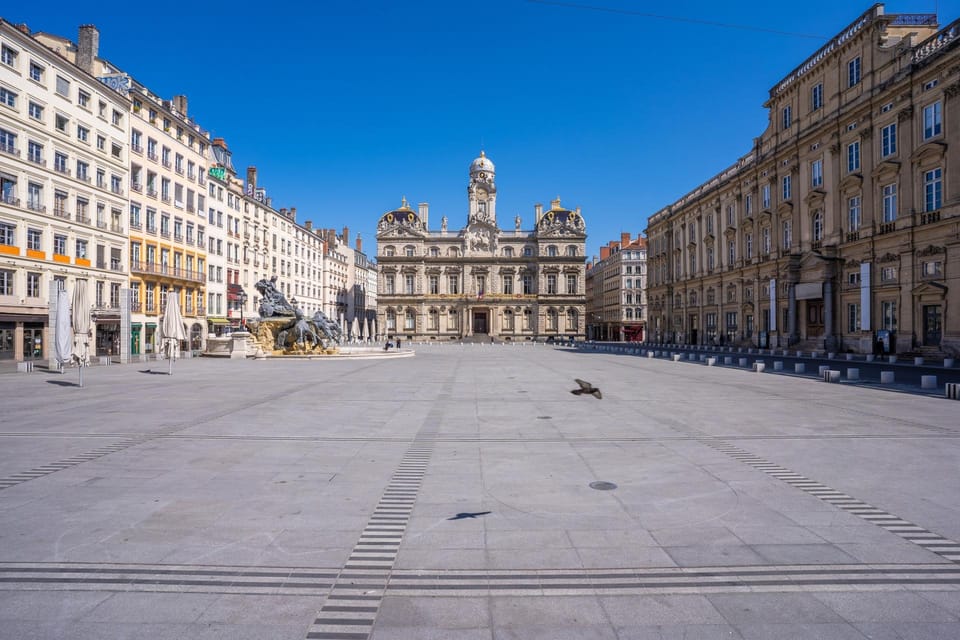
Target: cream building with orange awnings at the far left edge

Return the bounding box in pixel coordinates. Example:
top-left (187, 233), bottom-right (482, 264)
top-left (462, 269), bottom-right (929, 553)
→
top-left (0, 19), bottom-right (131, 361)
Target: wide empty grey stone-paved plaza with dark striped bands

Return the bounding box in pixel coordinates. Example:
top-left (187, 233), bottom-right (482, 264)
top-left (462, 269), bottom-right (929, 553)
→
top-left (0, 344), bottom-right (960, 640)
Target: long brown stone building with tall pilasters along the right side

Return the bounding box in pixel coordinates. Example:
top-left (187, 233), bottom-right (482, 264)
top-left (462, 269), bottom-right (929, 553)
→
top-left (647, 4), bottom-right (960, 356)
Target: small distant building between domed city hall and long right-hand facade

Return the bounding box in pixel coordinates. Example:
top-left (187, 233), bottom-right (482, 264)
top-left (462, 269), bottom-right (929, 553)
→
top-left (587, 233), bottom-right (647, 342)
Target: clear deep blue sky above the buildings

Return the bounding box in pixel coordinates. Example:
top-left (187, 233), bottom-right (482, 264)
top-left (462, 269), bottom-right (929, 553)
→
top-left (0, 0), bottom-right (960, 255)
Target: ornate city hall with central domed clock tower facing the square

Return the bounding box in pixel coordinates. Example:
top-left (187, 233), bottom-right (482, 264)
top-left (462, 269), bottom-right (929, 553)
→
top-left (377, 152), bottom-right (587, 341)
